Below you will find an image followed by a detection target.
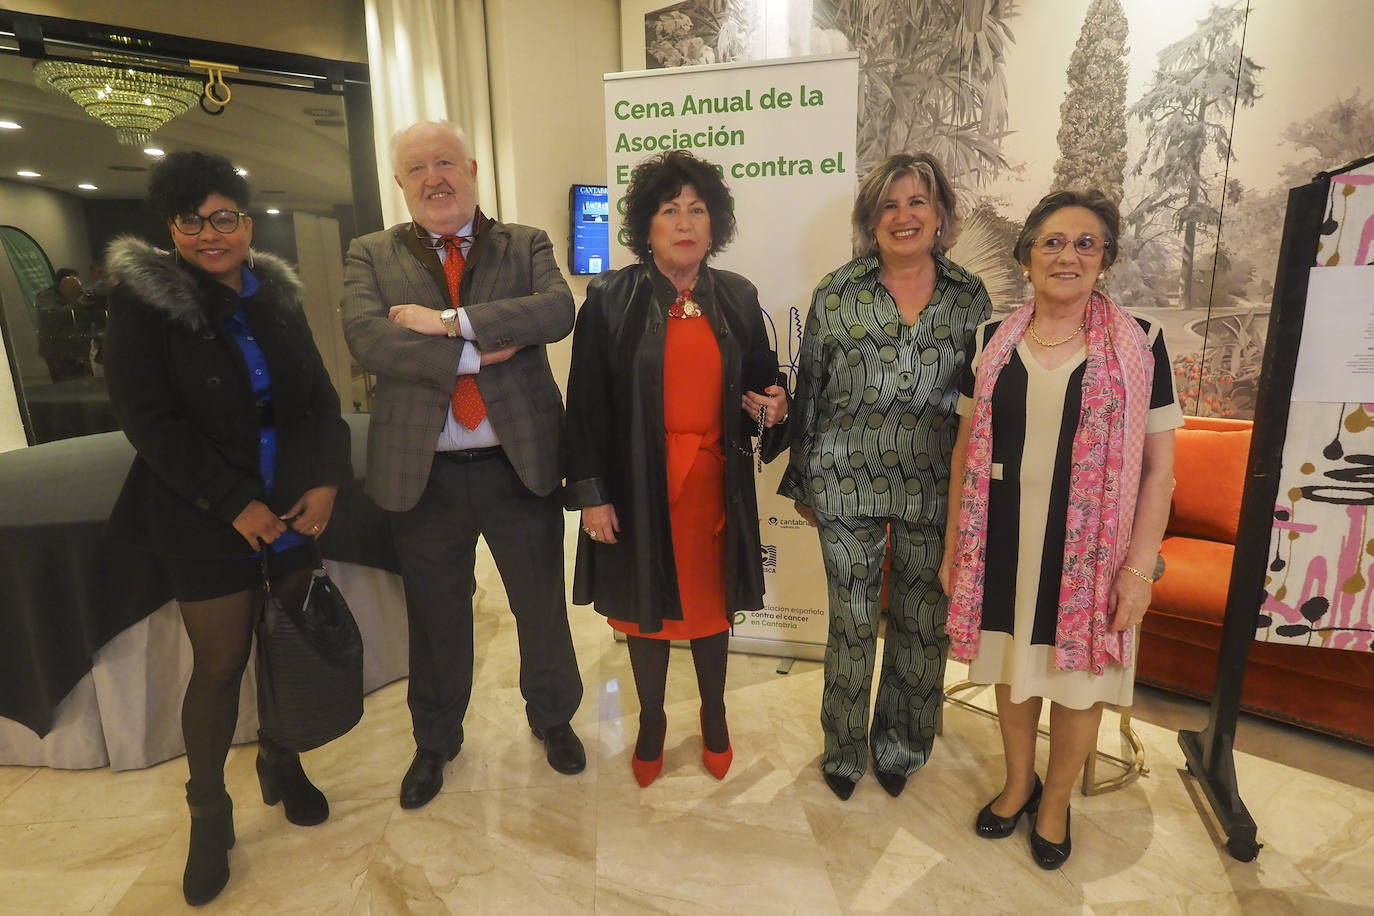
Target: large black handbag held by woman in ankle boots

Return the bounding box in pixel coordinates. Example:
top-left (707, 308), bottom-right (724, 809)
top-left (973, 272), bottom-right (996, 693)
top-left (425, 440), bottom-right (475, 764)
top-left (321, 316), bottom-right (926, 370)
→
top-left (257, 545), bottom-right (363, 751)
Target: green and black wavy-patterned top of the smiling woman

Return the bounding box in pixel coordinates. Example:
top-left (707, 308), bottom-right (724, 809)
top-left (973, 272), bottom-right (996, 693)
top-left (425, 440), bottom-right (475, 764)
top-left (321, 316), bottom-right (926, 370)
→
top-left (778, 255), bottom-right (992, 526)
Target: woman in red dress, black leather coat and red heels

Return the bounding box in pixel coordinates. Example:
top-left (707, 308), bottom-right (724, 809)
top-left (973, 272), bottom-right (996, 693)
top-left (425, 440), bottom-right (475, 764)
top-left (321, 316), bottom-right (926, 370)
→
top-left (566, 150), bottom-right (787, 786)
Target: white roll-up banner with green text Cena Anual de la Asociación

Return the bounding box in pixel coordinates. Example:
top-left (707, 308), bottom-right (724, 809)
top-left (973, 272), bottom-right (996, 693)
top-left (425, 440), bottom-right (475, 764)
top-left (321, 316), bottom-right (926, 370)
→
top-left (606, 54), bottom-right (859, 658)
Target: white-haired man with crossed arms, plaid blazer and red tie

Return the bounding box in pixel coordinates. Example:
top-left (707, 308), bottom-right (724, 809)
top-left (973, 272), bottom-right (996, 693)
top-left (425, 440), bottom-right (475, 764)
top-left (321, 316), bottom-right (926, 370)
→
top-left (342, 122), bottom-right (587, 808)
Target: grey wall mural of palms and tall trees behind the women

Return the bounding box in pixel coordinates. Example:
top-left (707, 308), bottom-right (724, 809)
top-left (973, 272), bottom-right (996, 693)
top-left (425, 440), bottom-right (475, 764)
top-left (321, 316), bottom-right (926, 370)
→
top-left (621, 0), bottom-right (1374, 417)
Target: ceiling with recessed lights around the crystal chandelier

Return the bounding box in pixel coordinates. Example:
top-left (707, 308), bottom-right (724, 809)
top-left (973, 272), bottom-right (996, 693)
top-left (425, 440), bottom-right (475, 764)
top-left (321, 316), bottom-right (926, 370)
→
top-left (0, 54), bottom-right (353, 214)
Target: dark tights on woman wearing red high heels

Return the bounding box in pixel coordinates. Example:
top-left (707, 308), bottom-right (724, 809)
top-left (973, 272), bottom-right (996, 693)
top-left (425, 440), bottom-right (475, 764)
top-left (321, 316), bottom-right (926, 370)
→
top-left (627, 630), bottom-right (730, 761)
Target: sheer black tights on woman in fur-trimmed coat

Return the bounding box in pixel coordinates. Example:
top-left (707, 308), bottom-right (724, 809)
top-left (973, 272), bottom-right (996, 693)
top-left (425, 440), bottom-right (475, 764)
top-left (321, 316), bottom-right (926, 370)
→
top-left (181, 569), bottom-right (311, 791)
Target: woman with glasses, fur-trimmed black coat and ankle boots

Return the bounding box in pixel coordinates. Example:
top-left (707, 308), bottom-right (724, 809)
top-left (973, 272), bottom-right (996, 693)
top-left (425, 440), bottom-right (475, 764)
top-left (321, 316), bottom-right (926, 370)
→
top-left (104, 152), bottom-right (353, 905)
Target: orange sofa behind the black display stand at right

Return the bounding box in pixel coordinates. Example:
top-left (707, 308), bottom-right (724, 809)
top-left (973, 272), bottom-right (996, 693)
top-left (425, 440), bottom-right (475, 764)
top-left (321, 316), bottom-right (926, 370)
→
top-left (1136, 416), bottom-right (1374, 746)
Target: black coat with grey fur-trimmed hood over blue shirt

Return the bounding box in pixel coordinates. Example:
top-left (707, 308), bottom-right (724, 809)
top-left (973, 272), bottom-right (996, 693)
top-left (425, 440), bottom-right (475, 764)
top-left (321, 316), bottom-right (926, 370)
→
top-left (104, 236), bottom-right (353, 559)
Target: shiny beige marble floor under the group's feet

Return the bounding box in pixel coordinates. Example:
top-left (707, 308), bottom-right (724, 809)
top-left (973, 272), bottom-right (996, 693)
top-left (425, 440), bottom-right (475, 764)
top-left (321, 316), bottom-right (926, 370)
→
top-left (0, 519), bottom-right (1374, 916)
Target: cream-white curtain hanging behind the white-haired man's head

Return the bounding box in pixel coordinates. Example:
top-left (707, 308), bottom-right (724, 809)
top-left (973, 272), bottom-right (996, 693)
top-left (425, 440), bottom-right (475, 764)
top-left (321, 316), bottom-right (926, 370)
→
top-left (364, 0), bottom-right (499, 225)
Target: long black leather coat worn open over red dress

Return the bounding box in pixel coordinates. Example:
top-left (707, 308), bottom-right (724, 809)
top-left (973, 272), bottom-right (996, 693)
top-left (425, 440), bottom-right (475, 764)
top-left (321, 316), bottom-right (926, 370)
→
top-left (565, 264), bottom-right (787, 633)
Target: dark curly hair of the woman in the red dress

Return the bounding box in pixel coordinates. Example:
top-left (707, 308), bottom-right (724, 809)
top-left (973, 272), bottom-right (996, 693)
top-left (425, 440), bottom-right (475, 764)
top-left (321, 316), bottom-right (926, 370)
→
top-left (624, 150), bottom-right (735, 264)
